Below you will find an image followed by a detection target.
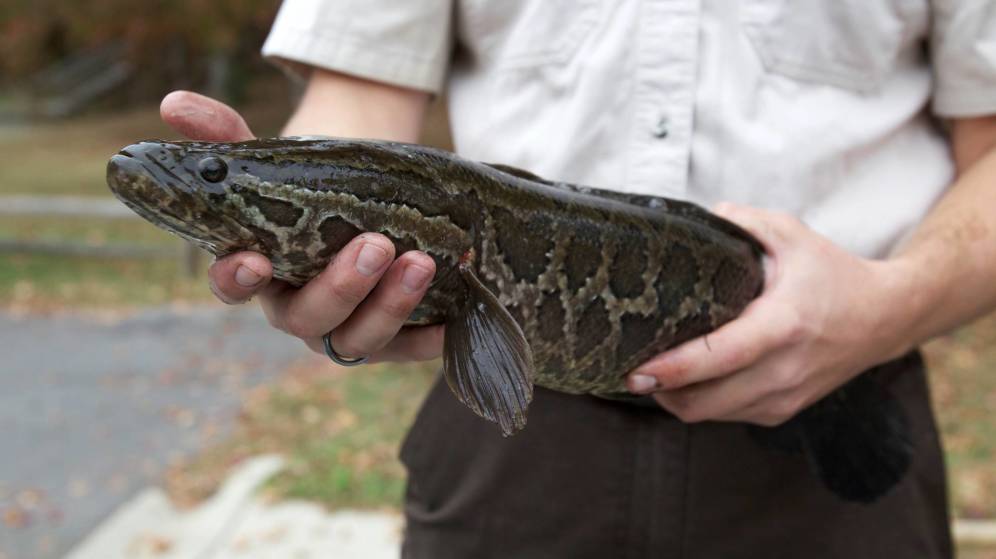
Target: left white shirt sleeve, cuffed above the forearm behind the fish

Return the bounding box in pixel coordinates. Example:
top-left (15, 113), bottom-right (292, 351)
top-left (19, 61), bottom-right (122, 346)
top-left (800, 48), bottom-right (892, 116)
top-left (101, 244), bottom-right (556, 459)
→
top-left (263, 0), bottom-right (453, 93)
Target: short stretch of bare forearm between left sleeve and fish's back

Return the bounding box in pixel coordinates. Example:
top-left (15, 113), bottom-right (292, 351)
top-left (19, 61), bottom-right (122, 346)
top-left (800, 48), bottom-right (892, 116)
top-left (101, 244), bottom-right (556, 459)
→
top-left (283, 69), bottom-right (429, 142)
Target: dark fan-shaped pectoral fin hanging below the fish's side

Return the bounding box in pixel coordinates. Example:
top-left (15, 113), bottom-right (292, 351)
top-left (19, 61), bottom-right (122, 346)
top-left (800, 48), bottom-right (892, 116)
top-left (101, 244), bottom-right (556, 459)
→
top-left (443, 265), bottom-right (533, 436)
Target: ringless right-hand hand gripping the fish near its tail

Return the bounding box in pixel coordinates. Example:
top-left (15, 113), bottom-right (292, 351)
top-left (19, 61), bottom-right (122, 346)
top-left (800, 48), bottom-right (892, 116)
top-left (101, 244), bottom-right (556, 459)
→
top-left (628, 204), bottom-right (910, 425)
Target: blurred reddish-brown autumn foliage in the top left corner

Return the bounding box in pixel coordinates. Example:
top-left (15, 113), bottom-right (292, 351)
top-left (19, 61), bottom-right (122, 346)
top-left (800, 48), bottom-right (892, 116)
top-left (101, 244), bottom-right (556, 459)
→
top-left (0, 0), bottom-right (279, 98)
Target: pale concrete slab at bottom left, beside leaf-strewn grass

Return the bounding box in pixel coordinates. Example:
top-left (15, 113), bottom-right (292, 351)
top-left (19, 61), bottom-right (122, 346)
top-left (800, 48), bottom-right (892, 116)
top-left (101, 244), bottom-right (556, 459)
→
top-left (67, 456), bottom-right (402, 559)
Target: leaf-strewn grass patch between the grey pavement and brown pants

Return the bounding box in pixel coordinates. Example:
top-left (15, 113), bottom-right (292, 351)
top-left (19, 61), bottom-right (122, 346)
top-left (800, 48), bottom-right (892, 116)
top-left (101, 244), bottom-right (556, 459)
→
top-left (167, 359), bottom-right (438, 508)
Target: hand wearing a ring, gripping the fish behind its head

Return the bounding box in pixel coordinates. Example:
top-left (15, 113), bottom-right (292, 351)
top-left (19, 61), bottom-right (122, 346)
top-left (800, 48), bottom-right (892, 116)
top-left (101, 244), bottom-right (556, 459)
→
top-left (160, 91), bottom-right (442, 361)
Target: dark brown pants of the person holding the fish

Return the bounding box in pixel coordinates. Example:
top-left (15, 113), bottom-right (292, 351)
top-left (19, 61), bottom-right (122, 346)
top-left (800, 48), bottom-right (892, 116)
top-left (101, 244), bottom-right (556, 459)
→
top-left (401, 354), bottom-right (952, 559)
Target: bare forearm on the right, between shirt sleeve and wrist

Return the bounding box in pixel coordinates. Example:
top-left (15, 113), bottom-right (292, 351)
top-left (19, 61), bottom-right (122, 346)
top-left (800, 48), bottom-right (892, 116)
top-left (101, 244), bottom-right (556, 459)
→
top-left (883, 118), bottom-right (996, 349)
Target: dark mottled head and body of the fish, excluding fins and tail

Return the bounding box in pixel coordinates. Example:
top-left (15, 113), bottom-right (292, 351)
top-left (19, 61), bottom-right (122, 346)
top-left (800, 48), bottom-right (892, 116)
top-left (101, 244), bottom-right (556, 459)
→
top-left (108, 139), bottom-right (763, 394)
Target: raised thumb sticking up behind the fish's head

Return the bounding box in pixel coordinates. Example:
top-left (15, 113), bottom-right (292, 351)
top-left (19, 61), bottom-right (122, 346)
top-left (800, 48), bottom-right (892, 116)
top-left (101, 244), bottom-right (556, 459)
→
top-left (159, 91), bottom-right (253, 142)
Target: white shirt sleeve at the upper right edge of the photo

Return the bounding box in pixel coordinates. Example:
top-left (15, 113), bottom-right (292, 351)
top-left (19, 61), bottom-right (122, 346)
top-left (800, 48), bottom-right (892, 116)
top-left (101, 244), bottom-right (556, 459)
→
top-left (930, 0), bottom-right (996, 117)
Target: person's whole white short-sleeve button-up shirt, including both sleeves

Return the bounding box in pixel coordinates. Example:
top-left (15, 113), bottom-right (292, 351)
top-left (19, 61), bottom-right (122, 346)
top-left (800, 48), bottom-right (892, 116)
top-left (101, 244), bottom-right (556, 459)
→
top-left (263, 0), bottom-right (996, 256)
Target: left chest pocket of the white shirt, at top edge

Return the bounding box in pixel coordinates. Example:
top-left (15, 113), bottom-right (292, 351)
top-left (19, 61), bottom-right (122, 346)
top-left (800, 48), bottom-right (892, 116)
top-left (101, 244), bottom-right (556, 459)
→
top-left (457, 0), bottom-right (599, 70)
